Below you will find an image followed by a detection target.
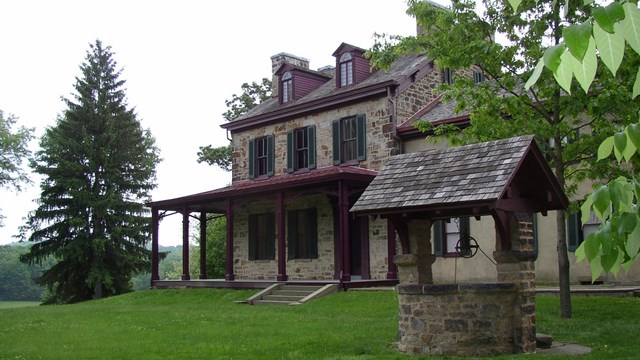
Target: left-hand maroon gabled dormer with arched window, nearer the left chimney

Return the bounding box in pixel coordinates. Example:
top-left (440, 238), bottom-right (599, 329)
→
top-left (274, 63), bottom-right (331, 105)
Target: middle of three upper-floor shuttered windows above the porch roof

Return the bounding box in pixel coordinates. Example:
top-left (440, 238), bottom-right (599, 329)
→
top-left (287, 125), bottom-right (316, 173)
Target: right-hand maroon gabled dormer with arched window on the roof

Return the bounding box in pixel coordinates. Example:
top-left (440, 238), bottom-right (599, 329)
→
top-left (333, 43), bottom-right (371, 88)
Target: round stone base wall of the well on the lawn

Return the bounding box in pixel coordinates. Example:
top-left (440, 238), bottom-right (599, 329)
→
top-left (398, 283), bottom-right (517, 356)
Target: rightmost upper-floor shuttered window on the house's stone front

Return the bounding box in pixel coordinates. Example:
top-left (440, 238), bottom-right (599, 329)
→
top-left (332, 114), bottom-right (366, 165)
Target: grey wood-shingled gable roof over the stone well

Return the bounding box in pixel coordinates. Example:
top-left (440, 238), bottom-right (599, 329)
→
top-left (351, 136), bottom-right (568, 219)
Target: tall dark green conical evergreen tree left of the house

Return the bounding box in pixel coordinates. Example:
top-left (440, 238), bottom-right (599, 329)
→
top-left (21, 40), bottom-right (160, 303)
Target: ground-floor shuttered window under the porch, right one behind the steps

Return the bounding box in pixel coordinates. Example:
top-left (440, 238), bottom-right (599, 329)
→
top-left (288, 209), bottom-right (318, 259)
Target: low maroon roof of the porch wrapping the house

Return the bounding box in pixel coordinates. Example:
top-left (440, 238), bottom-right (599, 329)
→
top-left (148, 166), bottom-right (378, 213)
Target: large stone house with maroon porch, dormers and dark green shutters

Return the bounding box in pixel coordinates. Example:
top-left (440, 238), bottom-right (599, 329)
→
top-left (150, 39), bottom-right (640, 284)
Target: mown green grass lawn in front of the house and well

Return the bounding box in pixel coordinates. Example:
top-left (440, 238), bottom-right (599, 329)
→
top-left (0, 289), bottom-right (640, 359)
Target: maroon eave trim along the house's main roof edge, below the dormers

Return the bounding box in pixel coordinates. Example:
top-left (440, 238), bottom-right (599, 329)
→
top-left (220, 80), bottom-right (397, 131)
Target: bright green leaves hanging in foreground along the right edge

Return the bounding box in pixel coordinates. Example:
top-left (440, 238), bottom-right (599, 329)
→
top-left (520, 0), bottom-right (640, 280)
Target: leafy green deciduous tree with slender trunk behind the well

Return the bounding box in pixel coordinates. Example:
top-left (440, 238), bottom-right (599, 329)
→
top-left (364, 0), bottom-right (638, 317)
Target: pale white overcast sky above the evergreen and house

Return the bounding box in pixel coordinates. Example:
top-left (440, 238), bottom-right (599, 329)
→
top-left (0, 0), bottom-right (446, 245)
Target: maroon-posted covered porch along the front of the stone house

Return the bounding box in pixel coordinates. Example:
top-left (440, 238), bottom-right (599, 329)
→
top-left (149, 166), bottom-right (397, 289)
